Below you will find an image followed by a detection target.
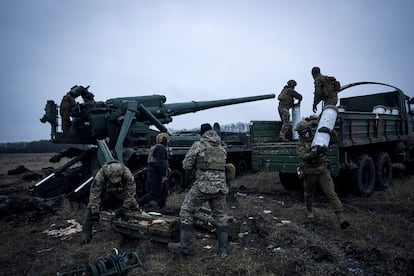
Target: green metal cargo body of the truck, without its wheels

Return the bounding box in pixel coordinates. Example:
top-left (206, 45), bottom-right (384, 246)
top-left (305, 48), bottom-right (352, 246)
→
top-left (251, 82), bottom-right (414, 177)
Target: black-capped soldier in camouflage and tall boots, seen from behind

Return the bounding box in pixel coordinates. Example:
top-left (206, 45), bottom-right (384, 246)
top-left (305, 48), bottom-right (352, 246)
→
top-left (168, 124), bottom-right (229, 258)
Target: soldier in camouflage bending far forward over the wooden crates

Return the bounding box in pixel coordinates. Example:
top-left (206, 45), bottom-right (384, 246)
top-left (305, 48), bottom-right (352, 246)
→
top-left (81, 160), bottom-right (140, 244)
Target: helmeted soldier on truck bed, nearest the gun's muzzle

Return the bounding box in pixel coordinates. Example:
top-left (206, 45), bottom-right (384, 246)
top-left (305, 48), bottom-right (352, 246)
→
top-left (278, 80), bottom-right (302, 142)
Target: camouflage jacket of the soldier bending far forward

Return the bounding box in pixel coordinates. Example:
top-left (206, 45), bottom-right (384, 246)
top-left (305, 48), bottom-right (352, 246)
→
top-left (88, 162), bottom-right (139, 213)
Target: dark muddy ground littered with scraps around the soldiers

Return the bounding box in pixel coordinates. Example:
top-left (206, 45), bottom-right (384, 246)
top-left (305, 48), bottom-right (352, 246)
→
top-left (0, 155), bottom-right (414, 275)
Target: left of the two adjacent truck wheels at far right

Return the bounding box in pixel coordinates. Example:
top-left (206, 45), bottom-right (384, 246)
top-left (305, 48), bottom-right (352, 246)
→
top-left (353, 154), bottom-right (375, 197)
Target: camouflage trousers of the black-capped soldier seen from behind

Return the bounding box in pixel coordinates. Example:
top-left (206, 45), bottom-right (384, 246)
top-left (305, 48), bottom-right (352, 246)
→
top-left (180, 185), bottom-right (227, 226)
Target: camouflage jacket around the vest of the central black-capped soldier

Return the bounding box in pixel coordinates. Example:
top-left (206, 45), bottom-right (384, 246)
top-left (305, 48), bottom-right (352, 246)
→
top-left (183, 130), bottom-right (229, 194)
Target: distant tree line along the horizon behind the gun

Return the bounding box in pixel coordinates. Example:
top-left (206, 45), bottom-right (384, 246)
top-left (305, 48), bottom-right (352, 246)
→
top-left (0, 122), bottom-right (250, 154)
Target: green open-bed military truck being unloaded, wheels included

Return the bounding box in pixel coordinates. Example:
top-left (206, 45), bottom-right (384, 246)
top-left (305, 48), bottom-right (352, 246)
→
top-left (251, 82), bottom-right (414, 196)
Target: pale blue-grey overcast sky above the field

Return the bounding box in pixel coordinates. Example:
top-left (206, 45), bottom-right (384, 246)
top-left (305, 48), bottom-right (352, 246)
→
top-left (0, 0), bottom-right (414, 142)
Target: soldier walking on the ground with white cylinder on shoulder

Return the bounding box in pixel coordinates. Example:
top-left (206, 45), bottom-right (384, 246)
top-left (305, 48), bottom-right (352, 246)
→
top-left (296, 119), bottom-right (350, 229)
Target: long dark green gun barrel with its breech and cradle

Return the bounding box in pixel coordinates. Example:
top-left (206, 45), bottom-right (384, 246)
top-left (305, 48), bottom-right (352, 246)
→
top-left (41, 91), bottom-right (275, 147)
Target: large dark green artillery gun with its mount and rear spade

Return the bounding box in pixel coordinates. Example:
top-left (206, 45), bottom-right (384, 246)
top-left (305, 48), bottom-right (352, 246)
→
top-left (34, 86), bottom-right (275, 199)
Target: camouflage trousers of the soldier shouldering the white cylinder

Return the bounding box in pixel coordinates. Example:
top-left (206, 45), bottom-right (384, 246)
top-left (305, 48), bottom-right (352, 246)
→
top-left (303, 169), bottom-right (343, 213)
